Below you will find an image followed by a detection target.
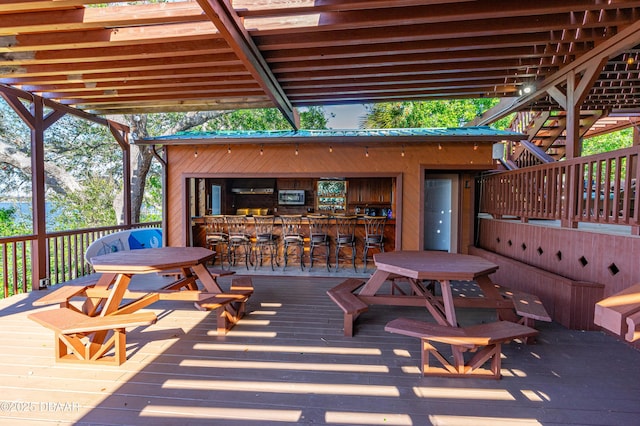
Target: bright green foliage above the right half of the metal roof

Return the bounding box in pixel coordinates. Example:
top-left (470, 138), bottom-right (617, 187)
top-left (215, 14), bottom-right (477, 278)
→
top-left (363, 99), bottom-right (510, 129)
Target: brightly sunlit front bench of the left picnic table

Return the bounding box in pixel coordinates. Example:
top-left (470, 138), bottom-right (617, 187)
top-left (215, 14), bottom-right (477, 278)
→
top-left (28, 307), bottom-right (157, 365)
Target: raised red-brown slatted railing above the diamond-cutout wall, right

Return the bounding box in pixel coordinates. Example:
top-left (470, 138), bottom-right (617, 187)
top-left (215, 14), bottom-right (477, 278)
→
top-left (480, 146), bottom-right (640, 235)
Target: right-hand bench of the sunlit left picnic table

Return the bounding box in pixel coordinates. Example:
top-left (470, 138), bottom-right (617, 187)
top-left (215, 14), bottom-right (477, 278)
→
top-left (195, 277), bottom-right (253, 335)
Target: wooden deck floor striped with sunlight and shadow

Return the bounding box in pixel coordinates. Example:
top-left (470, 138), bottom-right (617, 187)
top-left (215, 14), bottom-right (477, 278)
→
top-left (0, 275), bottom-right (640, 426)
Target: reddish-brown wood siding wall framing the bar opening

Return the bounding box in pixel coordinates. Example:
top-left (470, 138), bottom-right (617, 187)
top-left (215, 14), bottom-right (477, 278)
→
top-left (166, 142), bottom-right (493, 252)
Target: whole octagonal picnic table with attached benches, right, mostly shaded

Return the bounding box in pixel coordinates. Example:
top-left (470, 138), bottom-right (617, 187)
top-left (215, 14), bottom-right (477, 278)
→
top-left (327, 251), bottom-right (550, 379)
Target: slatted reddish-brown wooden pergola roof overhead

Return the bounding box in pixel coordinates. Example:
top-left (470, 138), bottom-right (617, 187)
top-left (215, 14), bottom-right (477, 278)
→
top-left (0, 0), bottom-right (640, 121)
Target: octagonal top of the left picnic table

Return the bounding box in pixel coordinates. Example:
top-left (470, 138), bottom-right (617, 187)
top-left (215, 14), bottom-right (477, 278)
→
top-left (91, 247), bottom-right (215, 274)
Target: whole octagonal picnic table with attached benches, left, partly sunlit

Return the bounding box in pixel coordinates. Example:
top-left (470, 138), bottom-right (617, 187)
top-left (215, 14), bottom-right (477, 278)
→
top-left (29, 247), bottom-right (253, 365)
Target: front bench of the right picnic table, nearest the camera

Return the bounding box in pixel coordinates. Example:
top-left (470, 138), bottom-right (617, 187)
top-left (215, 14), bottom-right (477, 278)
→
top-left (385, 318), bottom-right (538, 379)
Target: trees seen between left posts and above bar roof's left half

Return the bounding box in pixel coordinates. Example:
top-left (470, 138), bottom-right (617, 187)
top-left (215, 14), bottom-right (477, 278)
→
top-left (0, 102), bottom-right (327, 235)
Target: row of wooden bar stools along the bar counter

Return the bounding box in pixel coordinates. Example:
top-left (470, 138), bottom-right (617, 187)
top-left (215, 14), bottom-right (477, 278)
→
top-left (204, 215), bottom-right (386, 272)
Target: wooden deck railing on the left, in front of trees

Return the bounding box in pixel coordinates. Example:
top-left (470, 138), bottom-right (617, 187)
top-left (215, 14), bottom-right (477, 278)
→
top-left (0, 222), bottom-right (161, 298)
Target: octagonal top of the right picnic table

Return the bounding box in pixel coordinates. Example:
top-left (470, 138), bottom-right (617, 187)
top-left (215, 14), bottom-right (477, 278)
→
top-left (373, 250), bottom-right (498, 281)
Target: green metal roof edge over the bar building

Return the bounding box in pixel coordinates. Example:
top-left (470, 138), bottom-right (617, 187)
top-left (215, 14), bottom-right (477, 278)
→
top-left (138, 126), bottom-right (526, 144)
